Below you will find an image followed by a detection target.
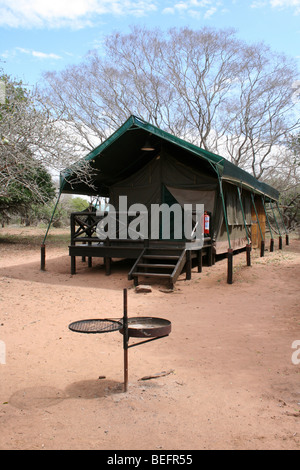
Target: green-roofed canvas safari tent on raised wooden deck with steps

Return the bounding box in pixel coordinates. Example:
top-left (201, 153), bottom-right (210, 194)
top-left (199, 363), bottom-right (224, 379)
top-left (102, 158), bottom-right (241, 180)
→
top-left (46, 116), bottom-right (279, 285)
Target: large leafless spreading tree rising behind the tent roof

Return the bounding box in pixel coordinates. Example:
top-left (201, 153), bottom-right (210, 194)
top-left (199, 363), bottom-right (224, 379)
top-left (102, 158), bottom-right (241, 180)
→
top-left (42, 27), bottom-right (299, 184)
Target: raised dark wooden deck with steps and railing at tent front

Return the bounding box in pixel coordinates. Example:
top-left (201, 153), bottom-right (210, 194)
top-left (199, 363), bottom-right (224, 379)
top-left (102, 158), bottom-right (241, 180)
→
top-left (69, 212), bottom-right (214, 288)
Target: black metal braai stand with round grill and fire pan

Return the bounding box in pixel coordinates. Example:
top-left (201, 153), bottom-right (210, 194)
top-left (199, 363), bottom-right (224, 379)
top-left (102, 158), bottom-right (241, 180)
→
top-left (69, 289), bottom-right (171, 392)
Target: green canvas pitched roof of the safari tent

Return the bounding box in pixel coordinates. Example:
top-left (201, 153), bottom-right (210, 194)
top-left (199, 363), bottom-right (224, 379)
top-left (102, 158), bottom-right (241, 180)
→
top-left (60, 116), bottom-right (279, 200)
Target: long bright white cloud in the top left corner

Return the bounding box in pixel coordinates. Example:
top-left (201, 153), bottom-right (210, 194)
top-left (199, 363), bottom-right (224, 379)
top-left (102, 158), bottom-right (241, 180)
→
top-left (0, 0), bottom-right (158, 28)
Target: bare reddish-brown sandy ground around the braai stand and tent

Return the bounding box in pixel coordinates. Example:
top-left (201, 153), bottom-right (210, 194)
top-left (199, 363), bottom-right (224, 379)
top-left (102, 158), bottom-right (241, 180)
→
top-left (0, 229), bottom-right (300, 451)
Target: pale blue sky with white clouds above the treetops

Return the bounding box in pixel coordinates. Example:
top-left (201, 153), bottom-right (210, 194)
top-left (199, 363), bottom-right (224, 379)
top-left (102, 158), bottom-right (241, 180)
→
top-left (0, 0), bottom-right (300, 86)
